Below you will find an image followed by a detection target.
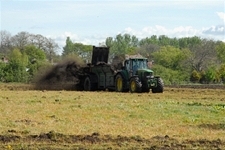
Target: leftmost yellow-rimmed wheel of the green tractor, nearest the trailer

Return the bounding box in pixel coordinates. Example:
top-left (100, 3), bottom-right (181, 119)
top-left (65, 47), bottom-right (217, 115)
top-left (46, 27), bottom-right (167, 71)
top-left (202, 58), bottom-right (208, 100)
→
top-left (115, 74), bottom-right (128, 92)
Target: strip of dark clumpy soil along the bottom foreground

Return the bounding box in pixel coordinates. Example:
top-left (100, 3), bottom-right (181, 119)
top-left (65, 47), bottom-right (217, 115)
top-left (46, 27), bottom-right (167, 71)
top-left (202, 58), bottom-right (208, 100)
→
top-left (0, 130), bottom-right (225, 150)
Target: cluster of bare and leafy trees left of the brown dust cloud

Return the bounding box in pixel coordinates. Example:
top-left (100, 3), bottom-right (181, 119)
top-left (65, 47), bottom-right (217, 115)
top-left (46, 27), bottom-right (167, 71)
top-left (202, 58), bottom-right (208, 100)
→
top-left (0, 31), bottom-right (59, 83)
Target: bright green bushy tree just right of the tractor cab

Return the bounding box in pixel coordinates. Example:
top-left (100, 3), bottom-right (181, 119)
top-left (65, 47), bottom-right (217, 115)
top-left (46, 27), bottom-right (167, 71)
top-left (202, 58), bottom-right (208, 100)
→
top-left (149, 46), bottom-right (190, 84)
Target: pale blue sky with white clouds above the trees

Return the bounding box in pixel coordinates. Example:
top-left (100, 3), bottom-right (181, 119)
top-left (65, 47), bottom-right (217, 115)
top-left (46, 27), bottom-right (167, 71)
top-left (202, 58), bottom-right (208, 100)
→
top-left (0, 0), bottom-right (225, 52)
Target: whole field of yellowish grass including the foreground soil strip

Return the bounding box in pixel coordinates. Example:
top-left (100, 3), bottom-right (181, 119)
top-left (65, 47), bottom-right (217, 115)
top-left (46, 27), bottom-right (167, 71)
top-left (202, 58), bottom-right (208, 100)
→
top-left (0, 84), bottom-right (225, 150)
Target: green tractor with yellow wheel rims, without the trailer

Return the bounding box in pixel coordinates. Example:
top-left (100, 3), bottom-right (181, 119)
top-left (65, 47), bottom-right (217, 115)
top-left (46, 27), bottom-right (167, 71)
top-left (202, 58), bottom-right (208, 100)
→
top-left (115, 58), bottom-right (164, 93)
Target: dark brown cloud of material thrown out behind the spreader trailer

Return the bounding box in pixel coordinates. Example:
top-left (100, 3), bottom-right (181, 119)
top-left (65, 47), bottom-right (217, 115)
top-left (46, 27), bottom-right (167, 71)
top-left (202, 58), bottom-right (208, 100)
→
top-left (34, 59), bottom-right (84, 90)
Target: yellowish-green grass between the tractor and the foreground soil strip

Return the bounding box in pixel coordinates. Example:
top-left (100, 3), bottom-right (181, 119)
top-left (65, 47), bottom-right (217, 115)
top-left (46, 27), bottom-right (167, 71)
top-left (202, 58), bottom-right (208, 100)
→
top-left (0, 88), bottom-right (225, 149)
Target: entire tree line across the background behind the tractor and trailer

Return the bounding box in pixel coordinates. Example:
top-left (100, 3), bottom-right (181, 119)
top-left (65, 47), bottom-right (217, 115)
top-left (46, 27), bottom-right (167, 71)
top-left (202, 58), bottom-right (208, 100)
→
top-left (0, 31), bottom-right (225, 85)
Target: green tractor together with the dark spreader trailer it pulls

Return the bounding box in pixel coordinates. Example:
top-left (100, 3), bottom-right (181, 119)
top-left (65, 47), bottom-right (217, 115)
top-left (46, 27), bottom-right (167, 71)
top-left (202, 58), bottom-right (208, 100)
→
top-left (78, 46), bottom-right (164, 93)
